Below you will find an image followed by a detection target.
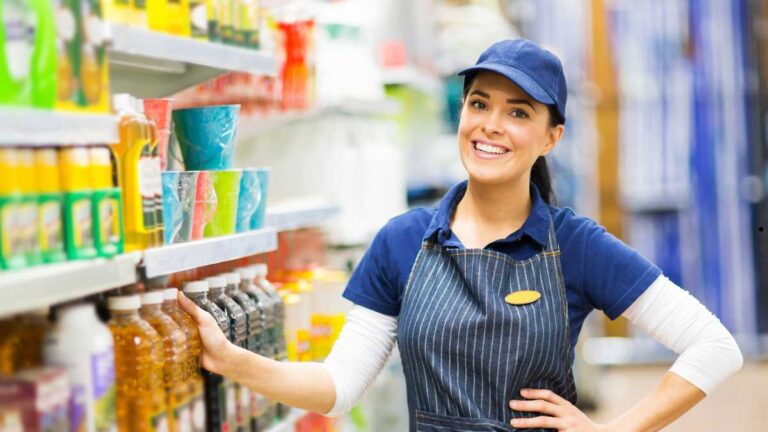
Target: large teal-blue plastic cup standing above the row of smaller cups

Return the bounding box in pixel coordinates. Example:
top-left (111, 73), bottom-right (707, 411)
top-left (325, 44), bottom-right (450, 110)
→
top-left (173, 105), bottom-right (240, 171)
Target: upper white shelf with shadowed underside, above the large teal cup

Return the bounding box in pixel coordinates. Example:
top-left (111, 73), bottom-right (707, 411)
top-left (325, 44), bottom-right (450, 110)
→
top-left (109, 24), bottom-right (277, 98)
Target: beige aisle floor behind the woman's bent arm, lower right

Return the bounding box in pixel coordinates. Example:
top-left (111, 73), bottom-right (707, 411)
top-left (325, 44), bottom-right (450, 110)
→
top-left (589, 362), bottom-right (768, 432)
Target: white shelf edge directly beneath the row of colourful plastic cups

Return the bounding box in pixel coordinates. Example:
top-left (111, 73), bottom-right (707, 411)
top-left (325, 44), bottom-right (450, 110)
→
top-left (141, 228), bottom-right (277, 278)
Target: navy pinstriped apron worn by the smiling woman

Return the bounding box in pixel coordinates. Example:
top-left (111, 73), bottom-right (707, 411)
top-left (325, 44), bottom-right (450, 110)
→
top-left (397, 220), bottom-right (576, 432)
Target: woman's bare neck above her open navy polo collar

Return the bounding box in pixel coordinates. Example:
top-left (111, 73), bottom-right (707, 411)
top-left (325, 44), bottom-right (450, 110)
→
top-left (451, 179), bottom-right (533, 247)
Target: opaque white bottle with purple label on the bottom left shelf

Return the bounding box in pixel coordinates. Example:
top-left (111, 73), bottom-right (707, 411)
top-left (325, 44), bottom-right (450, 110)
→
top-left (43, 303), bottom-right (117, 432)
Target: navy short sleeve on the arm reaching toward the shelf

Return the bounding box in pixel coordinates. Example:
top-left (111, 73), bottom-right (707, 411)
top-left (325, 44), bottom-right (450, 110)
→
top-left (343, 226), bottom-right (400, 316)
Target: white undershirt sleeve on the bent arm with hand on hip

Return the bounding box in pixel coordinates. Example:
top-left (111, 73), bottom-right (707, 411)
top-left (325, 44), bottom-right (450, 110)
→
top-left (623, 275), bottom-right (744, 394)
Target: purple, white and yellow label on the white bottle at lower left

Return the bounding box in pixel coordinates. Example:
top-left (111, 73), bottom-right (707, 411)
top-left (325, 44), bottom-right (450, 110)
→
top-left (91, 347), bottom-right (116, 432)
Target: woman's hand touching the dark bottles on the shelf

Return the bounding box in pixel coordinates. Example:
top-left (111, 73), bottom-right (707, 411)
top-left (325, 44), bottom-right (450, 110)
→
top-left (178, 291), bottom-right (234, 375)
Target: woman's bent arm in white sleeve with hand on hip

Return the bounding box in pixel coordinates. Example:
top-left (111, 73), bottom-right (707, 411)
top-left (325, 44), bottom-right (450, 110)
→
top-left (510, 276), bottom-right (743, 432)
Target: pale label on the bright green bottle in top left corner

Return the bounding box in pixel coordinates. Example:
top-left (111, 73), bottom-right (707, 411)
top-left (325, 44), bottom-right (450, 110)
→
top-left (2, 0), bottom-right (35, 81)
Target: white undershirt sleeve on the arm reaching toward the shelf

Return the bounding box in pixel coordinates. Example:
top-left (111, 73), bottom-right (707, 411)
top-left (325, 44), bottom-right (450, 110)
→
top-left (324, 305), bottom-right (397, 417)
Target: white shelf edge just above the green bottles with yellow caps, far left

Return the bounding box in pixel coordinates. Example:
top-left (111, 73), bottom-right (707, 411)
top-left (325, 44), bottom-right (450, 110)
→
top-left (0, 107), bottom-right (117, 146)
